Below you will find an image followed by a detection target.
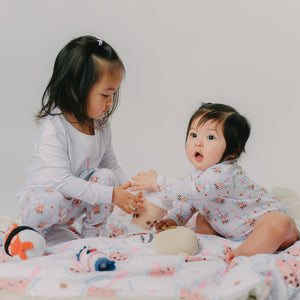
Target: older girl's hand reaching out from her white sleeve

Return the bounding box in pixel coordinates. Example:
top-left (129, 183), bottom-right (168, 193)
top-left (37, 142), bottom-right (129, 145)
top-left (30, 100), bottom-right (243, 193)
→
top-left (112, 182), bottom-right (144, 214)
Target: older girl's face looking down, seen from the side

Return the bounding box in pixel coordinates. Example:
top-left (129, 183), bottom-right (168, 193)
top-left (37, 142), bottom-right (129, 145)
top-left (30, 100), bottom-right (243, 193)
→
top-left (87, 70), bottom-right (123, 120)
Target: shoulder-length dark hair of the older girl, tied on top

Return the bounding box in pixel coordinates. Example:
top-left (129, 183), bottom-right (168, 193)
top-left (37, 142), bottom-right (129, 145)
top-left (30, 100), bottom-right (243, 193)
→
top-left (36, 36), bottom-right (125, 128)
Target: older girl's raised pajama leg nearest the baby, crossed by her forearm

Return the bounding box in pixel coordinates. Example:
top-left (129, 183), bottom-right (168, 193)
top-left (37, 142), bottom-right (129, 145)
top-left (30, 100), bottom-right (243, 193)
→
top-left (81, 169), bottom-right (119, 237)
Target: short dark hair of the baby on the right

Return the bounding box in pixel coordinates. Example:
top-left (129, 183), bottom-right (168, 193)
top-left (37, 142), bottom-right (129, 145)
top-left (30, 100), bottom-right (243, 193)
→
top-left (185, 103), bottom-right (251, 161)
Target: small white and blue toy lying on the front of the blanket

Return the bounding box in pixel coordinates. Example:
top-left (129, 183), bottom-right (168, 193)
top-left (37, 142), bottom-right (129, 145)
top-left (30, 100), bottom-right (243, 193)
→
top-left (77, 246), bottom-right (116, 271)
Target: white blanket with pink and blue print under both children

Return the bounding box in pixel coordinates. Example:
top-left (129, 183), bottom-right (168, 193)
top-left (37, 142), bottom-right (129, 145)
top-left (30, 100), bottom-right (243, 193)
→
top-left (0, 186), bottom-right (300, 300)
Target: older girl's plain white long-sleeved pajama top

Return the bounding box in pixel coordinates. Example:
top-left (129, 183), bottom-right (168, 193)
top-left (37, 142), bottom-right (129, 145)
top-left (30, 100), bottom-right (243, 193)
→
top-left (16, 110), bottom-right (127, 204)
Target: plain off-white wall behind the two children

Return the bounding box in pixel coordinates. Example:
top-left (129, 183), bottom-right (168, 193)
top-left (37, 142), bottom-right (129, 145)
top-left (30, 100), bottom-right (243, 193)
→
top-left (0, 0), bottom-right (300, 216)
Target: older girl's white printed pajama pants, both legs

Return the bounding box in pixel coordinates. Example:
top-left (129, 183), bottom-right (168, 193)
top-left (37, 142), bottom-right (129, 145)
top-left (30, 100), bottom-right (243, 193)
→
top-left (21, 169), bottom-right (118, 237)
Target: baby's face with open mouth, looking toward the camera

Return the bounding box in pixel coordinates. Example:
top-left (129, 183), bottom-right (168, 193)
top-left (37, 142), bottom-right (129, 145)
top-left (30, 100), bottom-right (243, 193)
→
top-left (186, 116), bottom-right (226, 171)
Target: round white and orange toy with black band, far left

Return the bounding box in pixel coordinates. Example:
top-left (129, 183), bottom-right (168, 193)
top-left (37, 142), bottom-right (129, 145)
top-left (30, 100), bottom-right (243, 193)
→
top-left (3, 223), bottom-right (46, 260)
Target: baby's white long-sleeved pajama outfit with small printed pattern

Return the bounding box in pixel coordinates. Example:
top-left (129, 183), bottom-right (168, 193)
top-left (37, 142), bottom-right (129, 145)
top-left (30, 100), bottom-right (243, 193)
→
top-left (157, 160), bottom-right (288, 241)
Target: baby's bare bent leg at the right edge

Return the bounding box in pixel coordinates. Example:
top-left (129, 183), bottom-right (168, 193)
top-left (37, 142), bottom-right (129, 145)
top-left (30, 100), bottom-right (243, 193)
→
top-left (225, 211), bottom-right (298, 263)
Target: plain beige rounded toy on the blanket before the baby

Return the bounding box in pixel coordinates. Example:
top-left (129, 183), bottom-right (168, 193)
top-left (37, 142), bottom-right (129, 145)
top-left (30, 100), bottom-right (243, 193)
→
top-left (153, 226), bottom-right (199, 255)
